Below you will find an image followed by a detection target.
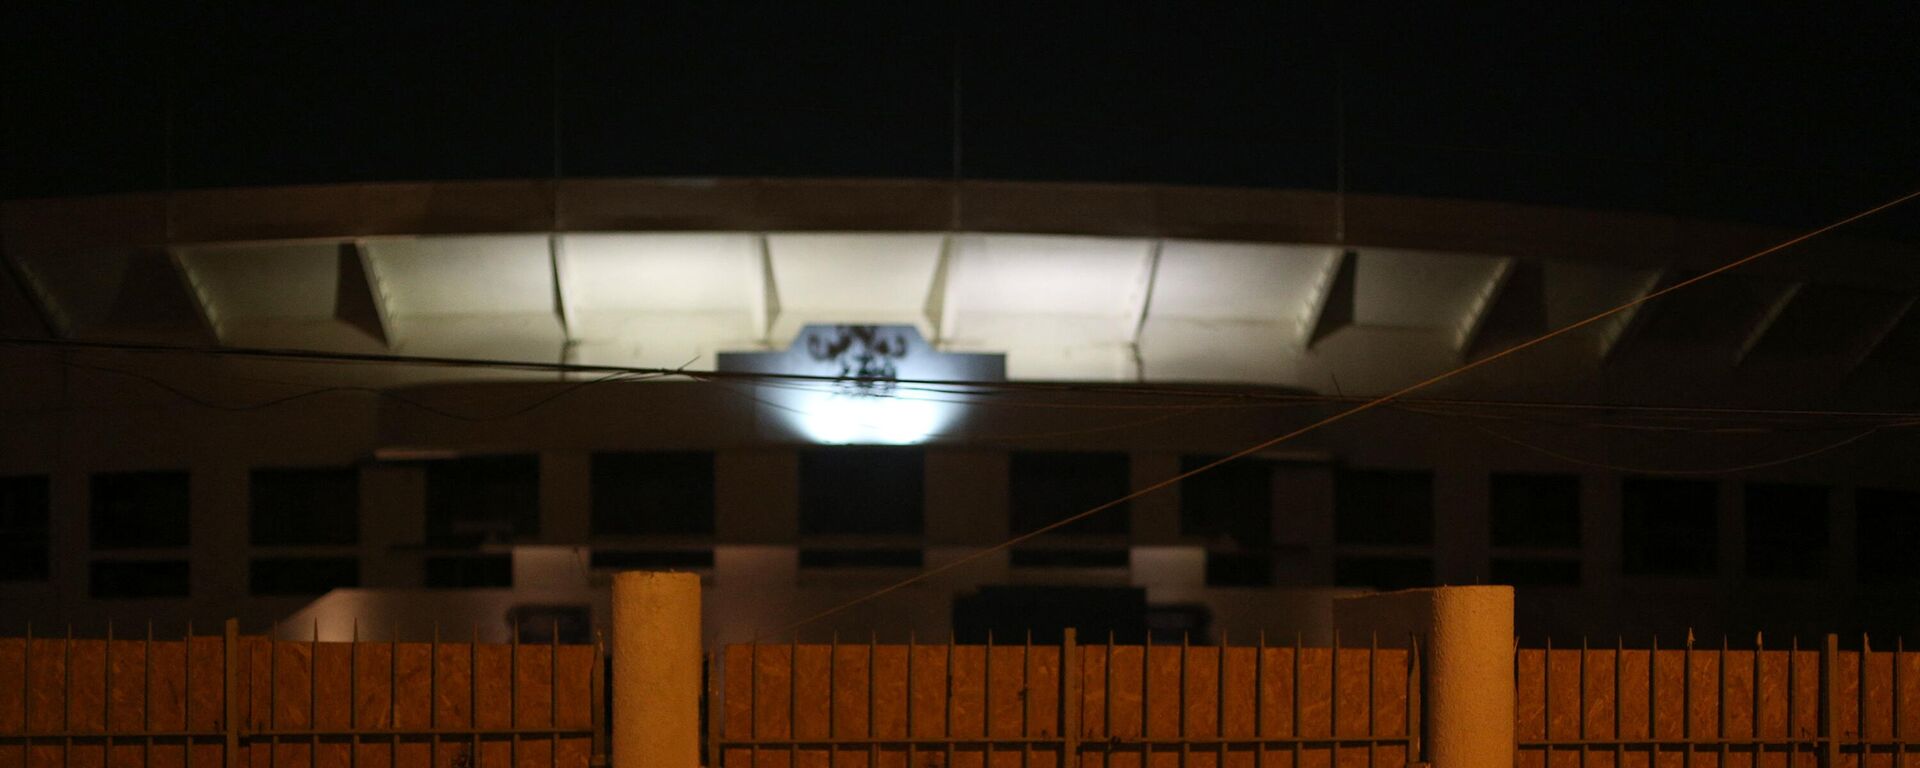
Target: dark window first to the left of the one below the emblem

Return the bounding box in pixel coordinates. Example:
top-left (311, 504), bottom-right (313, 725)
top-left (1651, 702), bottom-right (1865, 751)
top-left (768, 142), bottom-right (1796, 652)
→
top-left (593, 451), bottom-right (714, 536)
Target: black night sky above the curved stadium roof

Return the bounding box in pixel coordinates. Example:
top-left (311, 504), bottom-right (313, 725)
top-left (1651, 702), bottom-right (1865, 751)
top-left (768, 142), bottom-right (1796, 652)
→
top-left (0, 2), bottom-right (1920, 234)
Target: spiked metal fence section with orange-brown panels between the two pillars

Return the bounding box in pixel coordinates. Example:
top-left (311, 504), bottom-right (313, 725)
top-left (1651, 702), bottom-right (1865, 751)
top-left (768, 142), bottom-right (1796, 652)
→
top-left (707, 632), bottom-right (1421, 768)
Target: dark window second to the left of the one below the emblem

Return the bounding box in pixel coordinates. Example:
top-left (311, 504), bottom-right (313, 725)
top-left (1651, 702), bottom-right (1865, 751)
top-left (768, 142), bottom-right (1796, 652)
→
top-left (426, 455), bottom-right (540, 543)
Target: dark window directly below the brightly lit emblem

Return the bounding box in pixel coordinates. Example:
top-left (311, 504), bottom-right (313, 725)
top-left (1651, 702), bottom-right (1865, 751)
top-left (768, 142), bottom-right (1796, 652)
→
top-left (801, 447), bottom-right (925, 534)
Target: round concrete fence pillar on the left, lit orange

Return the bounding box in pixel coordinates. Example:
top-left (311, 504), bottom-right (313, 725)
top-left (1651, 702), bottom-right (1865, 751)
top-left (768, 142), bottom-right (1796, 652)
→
top-left (612, 570), bottom-right (702, 768)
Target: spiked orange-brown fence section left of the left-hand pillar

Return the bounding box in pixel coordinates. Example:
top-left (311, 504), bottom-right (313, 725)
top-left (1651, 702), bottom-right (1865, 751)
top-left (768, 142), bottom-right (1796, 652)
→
top-left (0, 622), bottom-right (607, 768)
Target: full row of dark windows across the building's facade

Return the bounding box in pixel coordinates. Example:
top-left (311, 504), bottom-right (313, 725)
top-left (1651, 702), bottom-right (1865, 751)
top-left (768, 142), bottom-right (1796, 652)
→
top-left (0, 458), bottom-right (1920, 593)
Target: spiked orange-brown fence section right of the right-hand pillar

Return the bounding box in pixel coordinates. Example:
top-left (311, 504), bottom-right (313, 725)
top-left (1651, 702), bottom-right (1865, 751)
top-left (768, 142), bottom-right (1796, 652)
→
top-left (1515, 636), bottom-right (1920, 768)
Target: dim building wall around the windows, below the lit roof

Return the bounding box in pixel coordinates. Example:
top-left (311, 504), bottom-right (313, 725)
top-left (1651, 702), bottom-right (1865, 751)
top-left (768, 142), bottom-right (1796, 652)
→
top-left (0, 355), bottom-right (1920, 641)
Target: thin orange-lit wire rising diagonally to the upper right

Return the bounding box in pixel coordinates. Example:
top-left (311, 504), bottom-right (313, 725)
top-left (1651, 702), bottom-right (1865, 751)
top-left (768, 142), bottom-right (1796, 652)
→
top-left (756, 190), bottom-right (1920, 637)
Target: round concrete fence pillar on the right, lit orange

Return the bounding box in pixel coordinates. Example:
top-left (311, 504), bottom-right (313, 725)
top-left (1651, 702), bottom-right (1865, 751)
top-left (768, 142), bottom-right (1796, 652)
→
top-left (1332, 586), bottom-right (1515, 768)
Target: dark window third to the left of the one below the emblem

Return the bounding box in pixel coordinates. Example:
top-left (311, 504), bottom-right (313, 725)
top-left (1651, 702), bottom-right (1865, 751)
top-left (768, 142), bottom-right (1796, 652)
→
top-left (250, 467), bottom-right (359, 547)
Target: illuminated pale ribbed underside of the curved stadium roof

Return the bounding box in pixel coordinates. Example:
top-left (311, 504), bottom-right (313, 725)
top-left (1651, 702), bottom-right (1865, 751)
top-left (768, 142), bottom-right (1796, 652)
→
top-left (15, 232), bottom-right (1912, 401)
